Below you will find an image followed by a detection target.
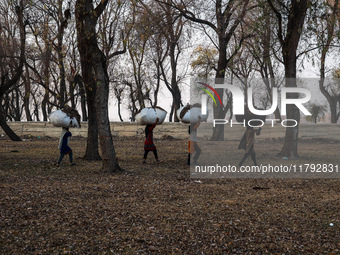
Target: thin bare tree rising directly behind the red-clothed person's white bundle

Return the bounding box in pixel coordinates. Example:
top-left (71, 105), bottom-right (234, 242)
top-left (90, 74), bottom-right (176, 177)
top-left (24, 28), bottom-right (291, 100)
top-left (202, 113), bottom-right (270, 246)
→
top-left (114, 3), bottom-right (166, 121)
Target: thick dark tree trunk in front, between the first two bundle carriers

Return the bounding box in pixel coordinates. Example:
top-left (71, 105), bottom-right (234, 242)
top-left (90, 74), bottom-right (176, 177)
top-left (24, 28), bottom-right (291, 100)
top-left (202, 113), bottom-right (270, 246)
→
top-left (75, 0), bottom-right (121, 173)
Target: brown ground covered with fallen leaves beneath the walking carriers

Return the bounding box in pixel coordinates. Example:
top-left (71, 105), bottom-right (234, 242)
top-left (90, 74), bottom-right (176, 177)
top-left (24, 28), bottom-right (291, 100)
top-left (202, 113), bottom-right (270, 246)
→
top-left (0, 134), bottom-right (340, 254)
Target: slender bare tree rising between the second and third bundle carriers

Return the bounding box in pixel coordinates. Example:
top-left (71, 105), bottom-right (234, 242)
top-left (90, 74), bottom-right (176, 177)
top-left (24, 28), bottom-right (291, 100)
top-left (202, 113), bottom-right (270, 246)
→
top-left (140, 0), bottom-right (185, 122)
